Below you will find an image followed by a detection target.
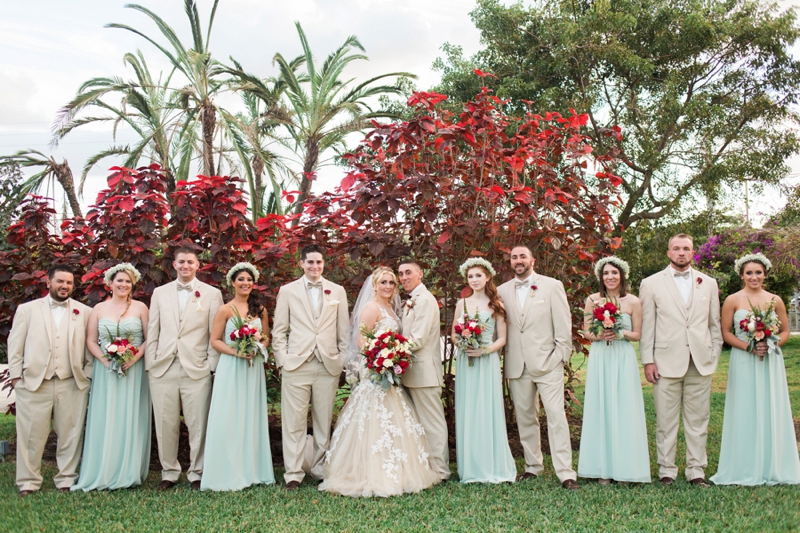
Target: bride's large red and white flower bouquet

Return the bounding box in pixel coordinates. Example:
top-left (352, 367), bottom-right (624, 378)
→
top-left (361, 324), bottom-right (412, 390)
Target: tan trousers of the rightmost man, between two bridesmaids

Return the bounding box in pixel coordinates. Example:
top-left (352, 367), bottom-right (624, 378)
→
top-left (653, 358), bottom-right (711, 481)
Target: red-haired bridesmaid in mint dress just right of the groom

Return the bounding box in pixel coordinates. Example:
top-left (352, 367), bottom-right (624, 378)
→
top-left (451, 257), bottom-right (517, 483)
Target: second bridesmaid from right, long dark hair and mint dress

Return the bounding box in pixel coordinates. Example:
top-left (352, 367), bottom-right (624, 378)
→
top-left (578, 256), bottom-right (650, 485)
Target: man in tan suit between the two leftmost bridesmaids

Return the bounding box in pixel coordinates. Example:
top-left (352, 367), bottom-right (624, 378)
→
top-left (144, 248), bottom-right (222, 490)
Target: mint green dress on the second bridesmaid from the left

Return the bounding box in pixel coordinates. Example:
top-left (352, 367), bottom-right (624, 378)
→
top-left (200, 318), bottom-right (275, 491)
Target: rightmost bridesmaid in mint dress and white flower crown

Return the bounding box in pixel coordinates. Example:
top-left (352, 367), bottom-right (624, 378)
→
top-left (711, 254), bottom-right (800, 485)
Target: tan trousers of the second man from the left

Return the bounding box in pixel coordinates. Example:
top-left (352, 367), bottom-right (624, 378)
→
top-left (148, 357), bottom-right (211, 483)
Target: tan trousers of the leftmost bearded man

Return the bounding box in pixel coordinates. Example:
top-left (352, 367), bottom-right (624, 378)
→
top-left (14, 376), bottom-right (88, 491)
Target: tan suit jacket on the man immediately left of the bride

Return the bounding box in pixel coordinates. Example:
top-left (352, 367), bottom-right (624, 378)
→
top-left (272, 278), bottom-right (350, 376)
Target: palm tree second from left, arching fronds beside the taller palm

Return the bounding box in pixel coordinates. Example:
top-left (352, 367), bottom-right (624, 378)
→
top-left (53, 50), bottom-right (180, 194)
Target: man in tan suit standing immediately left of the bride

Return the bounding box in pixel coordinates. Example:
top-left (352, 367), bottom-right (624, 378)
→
top-left (272, 245), bottom-right (350, 490)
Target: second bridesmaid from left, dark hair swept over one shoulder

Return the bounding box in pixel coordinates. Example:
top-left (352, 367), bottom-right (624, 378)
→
top-left (200, 263), bottom-right (275, 490)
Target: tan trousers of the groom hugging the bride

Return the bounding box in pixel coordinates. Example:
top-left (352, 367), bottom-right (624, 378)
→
top-left (405, 387), bottom-right (450, 480)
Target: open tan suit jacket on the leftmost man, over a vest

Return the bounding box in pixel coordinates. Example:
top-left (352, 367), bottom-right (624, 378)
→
top-left (8, 296), bottom-right (94, 392)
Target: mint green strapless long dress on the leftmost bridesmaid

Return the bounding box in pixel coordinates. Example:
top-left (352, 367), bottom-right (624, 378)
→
top-left (72, 317), bottom-right (153, 491)
